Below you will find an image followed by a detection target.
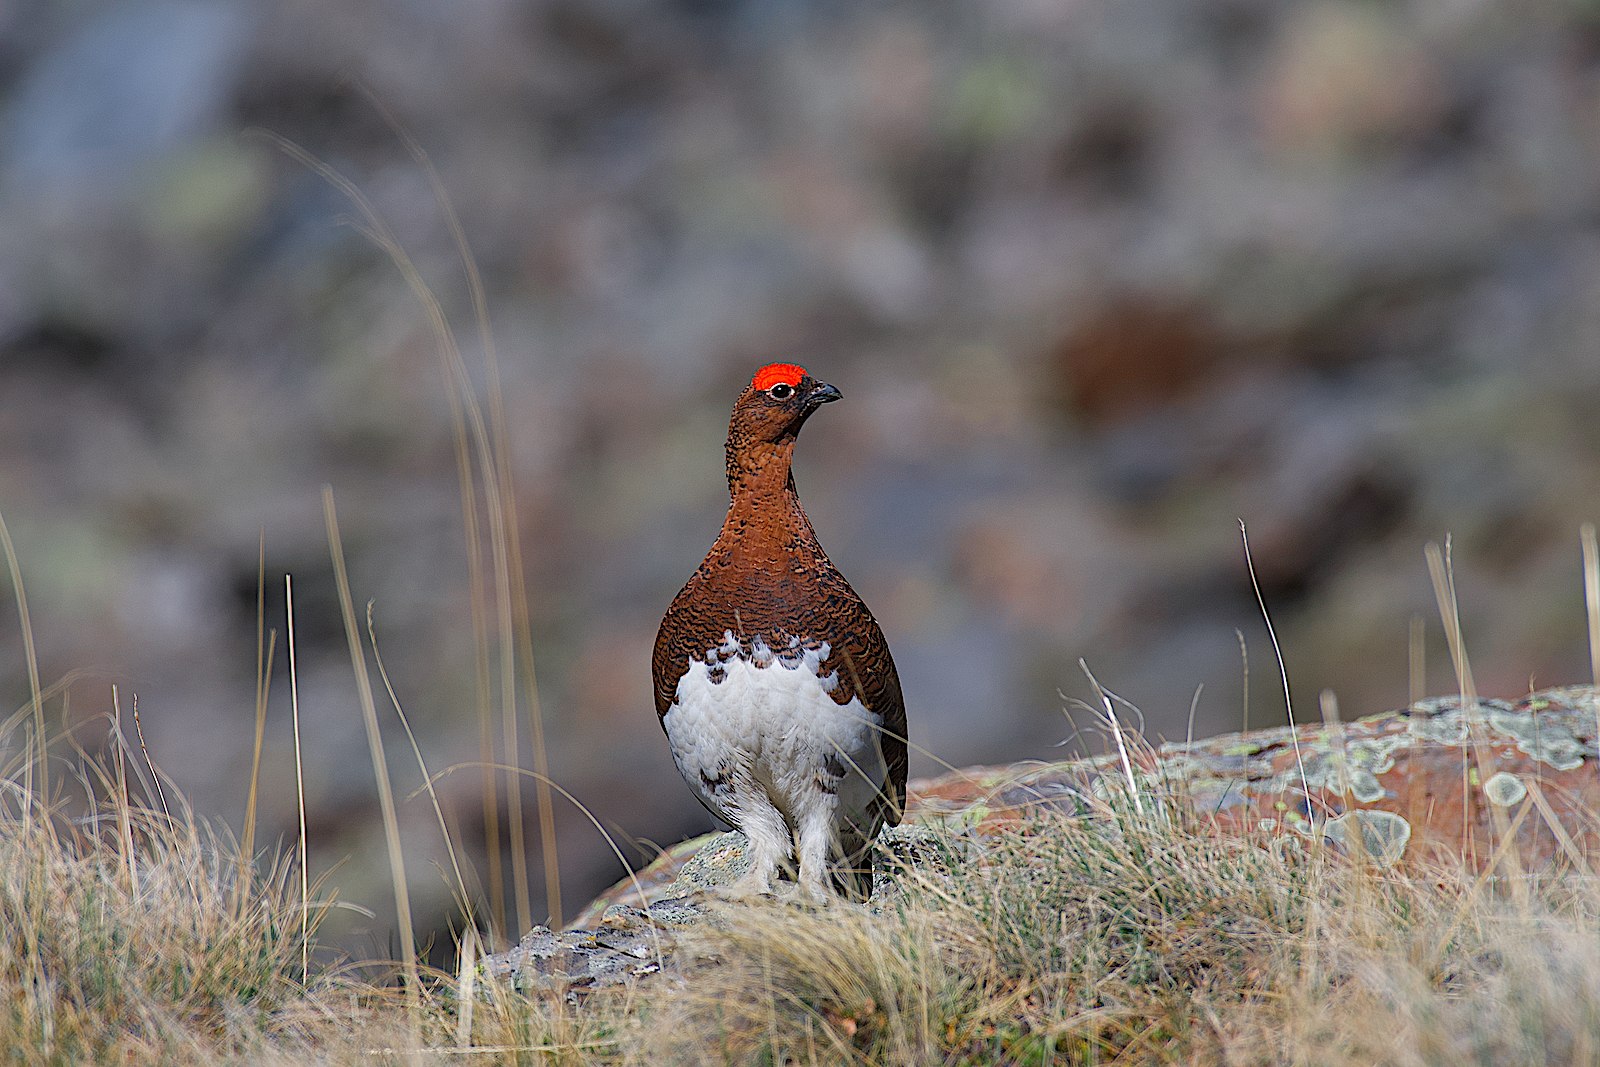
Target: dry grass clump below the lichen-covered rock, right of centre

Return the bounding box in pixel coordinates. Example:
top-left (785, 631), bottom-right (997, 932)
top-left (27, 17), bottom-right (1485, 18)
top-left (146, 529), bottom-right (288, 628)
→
top-left (595, 783), bottom-right (1600, 1064)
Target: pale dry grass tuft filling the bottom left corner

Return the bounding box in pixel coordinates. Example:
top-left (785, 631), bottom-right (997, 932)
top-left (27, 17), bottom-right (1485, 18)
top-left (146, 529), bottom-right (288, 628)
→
top-left (0, 733), bottom-right (350, 1064)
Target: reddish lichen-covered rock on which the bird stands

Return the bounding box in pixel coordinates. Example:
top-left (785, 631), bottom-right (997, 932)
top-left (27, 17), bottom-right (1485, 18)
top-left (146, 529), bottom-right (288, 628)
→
top-left (560, 686), bottom-right (1600, 929)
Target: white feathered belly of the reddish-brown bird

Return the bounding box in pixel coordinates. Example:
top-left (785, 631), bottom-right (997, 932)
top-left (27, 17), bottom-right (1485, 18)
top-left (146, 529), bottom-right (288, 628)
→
top-left (662, 633), bottom-right (888, 851)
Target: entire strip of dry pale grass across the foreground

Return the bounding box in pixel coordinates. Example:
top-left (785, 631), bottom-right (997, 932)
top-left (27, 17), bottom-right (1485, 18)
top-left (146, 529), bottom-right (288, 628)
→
top-left (0, 687), bottom-right (1600, 1065)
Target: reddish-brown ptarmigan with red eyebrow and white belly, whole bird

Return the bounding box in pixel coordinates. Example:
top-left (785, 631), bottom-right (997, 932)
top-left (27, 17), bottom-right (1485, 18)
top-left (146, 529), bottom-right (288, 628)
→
top-left (651, 363), bottom-right (906, 899)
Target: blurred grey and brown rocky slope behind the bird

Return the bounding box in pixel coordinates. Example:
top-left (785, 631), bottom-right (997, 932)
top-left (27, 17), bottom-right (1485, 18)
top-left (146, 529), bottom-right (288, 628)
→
top-left (0, 0), bottom-right (1600, 953)
